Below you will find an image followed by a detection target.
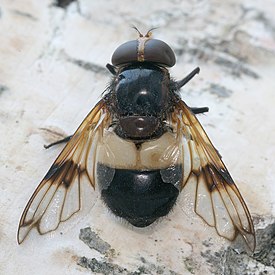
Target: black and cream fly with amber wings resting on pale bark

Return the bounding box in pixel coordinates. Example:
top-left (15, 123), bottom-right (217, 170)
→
top-left (18, 30), bottom-right (255, 250)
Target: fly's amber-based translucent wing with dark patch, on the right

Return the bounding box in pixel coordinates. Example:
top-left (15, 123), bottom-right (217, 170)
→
top-left (175, 101), bottom-right (256, 251)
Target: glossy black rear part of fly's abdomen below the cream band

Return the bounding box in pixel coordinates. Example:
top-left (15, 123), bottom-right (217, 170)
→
top-left (98, 164), bottom-right (179, 227)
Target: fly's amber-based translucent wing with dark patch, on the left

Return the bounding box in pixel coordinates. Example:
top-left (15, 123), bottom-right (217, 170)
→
top-left (17, 100), bottom-right (109, 244)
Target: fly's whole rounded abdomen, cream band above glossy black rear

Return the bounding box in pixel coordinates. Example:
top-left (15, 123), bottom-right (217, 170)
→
top-left (97, 131), bottom-right (183, 227)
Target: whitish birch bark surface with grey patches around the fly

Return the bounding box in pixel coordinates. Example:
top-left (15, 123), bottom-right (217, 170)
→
top-left (0, 0), bottom-right (275, 275)
